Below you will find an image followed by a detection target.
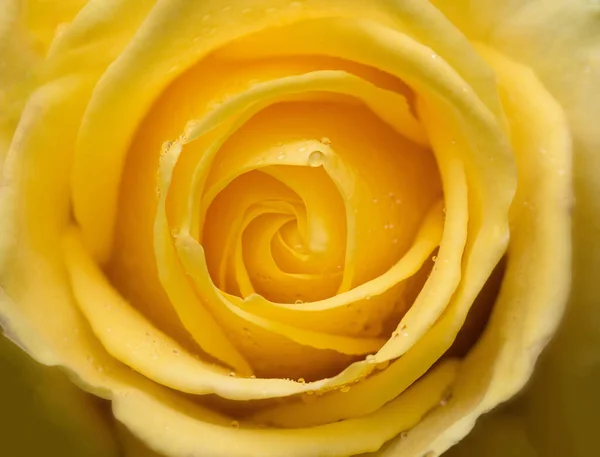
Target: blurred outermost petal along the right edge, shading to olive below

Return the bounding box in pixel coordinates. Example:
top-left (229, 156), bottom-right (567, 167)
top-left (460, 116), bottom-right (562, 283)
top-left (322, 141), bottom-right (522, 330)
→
top-left (433, 0), bottom-right (600, 457)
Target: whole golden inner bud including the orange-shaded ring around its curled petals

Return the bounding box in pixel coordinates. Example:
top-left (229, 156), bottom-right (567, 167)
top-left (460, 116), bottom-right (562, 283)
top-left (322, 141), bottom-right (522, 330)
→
top-left (107, 50), bottom-right (452, 380)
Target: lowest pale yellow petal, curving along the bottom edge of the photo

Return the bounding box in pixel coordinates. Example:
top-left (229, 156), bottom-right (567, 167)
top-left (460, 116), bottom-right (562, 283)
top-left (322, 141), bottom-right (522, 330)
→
top-left (113, 363), bottom-right (458, 457)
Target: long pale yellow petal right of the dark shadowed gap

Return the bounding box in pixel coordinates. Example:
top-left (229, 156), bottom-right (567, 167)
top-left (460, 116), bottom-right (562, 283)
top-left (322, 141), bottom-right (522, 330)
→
top-left (383, 47), bottom-right (572, 457)
